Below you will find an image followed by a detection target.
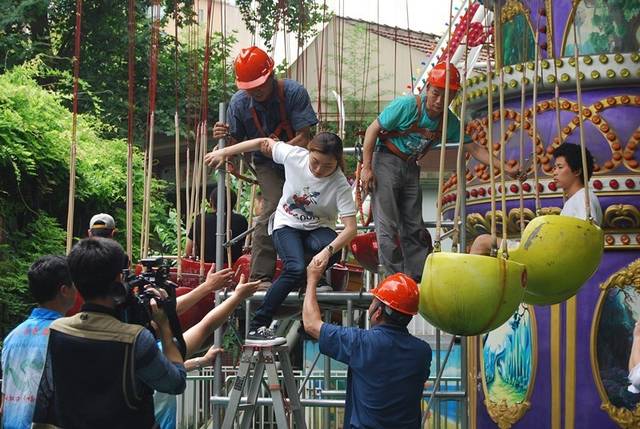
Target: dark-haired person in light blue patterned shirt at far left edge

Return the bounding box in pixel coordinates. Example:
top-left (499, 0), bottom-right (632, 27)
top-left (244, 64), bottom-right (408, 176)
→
top-left (0, 255), bottom-right (76, 429)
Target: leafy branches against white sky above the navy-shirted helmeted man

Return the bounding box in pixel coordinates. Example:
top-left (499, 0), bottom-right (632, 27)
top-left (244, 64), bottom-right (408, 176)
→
top-left (236, 0), bottom-right (332, 49)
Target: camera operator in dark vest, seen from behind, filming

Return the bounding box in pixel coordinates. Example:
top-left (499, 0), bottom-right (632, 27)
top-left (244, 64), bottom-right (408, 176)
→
top-left (33, 238), bottom-right (186, 429)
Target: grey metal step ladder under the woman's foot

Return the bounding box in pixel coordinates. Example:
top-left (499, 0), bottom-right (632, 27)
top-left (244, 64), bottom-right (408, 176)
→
top-left (222, 345), bottom-right (306, 429)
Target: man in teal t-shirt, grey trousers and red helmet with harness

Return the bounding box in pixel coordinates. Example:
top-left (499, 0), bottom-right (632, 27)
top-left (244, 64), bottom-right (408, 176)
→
top-left (361, 63), bottom-right (517, 280)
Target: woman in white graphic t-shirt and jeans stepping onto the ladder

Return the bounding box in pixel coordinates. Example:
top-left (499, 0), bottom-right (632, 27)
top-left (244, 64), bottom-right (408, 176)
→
top-left (205, 132), bottom-right (356, 345)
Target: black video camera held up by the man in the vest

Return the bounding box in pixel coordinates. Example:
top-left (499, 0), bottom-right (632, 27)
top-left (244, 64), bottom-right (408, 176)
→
top-left (116, 257), bottom-right (186, 358)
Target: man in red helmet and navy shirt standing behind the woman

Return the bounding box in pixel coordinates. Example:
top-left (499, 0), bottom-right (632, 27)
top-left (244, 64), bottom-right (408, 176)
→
top-left (213, 46), bottom-right (318, 285)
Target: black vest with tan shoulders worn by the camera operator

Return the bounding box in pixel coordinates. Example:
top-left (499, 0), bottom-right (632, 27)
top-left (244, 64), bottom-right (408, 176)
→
top-left (43, 311), bottom-right (157, 429)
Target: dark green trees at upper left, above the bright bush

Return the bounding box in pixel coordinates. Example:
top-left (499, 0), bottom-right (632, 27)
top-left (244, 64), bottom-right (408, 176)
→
top-left (0, 0), bottom-right (236, 144)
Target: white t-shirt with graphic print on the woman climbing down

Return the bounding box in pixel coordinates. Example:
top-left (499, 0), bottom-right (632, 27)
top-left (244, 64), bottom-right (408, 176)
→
top-left (270, 142), bottom-right (356, 231)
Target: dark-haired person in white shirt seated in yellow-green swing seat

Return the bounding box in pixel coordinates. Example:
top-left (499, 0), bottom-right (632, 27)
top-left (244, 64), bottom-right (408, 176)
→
top-left (469, 143), bottom-right (602, 255)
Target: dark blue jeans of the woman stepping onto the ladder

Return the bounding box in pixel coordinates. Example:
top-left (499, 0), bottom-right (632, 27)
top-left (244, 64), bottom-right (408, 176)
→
top-left (251, 226), bottom-right (340, 330)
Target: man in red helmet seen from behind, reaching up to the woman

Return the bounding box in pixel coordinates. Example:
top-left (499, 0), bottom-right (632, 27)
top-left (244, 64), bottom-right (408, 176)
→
top-left (302, 263), bottom-right (431, 429)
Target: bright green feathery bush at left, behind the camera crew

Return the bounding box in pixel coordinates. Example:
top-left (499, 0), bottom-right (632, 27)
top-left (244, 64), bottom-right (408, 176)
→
top-left (0, 61), bottom-right (167, 332)
